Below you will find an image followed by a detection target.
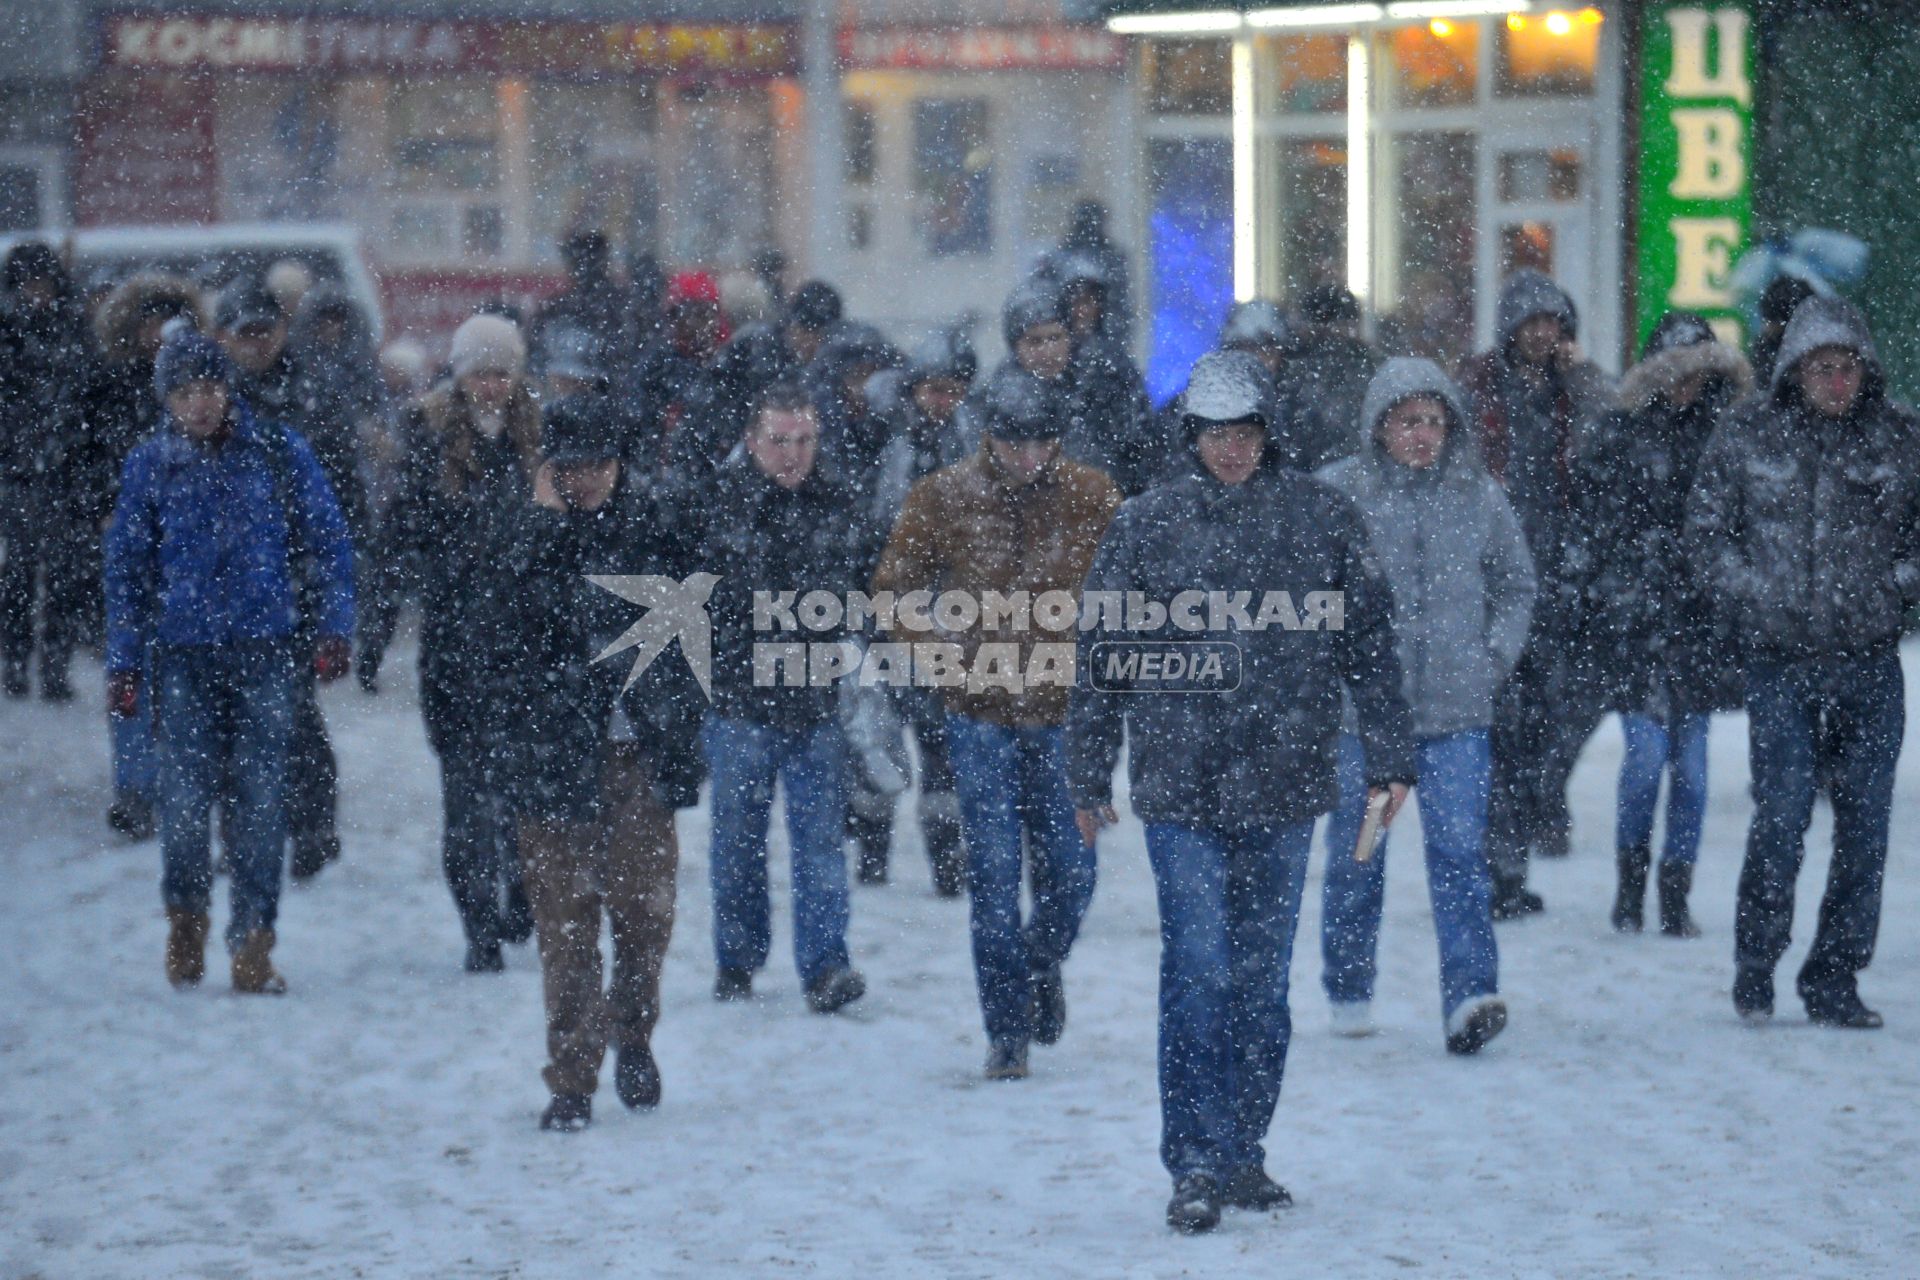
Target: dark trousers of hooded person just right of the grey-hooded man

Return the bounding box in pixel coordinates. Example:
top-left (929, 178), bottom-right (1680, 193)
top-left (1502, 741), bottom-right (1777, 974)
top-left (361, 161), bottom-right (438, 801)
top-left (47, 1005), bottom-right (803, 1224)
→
top-left (1486, 629), bottom-right (1605, 883)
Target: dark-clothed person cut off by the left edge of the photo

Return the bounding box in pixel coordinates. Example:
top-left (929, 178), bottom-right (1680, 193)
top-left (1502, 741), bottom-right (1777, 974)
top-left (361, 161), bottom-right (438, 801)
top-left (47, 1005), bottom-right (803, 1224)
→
top-left (0, 240), bottom-right (100, 702)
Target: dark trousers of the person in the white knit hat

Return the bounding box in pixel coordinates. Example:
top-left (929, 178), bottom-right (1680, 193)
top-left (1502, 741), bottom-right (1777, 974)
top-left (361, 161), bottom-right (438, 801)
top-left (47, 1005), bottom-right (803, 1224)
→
top-left (440, 737), bottom-right (520, 944)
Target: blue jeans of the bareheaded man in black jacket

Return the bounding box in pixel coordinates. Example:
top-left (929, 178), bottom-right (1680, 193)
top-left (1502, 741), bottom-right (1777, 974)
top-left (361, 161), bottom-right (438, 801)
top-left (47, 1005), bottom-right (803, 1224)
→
top-left (703, 716), bottom-right (849, 986)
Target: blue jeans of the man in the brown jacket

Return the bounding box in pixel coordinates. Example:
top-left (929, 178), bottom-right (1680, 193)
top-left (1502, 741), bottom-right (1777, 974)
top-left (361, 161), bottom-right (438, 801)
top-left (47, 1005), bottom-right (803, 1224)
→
top-left (947, 716), bottom-right (1094, 1040)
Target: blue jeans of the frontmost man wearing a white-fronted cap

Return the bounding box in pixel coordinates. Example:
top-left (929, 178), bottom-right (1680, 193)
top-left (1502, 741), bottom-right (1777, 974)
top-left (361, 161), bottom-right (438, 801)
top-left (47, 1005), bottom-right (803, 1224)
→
top-left (1146, 821), bottom-right (1313, 1180)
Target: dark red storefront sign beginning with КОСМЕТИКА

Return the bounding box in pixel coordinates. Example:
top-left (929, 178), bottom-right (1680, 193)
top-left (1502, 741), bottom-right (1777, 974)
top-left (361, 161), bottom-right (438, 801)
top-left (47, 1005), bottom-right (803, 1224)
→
top-left (100, 13), bottom-right (799, 77)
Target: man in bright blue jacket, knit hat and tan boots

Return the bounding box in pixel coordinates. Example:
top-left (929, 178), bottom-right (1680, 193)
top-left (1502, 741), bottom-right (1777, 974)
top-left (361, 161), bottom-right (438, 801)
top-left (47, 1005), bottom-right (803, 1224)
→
top-left (106, 330), bottom-right (353, 994)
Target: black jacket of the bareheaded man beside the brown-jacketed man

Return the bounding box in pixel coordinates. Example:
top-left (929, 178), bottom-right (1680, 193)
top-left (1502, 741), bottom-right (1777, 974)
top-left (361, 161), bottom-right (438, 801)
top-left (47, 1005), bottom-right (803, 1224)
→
top-left (674, 455), bottom-right (879, 731)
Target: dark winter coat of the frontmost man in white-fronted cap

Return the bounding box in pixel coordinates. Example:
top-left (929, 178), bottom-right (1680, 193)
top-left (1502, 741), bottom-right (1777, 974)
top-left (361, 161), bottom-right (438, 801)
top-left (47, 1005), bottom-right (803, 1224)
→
top-left (1068, 461), bottom-right (1413, 827)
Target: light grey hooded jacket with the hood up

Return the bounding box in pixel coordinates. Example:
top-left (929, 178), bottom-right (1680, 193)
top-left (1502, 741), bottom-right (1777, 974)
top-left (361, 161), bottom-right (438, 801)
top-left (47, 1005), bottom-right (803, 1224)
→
top-left (1319, 357), bottom-right (1534, 739)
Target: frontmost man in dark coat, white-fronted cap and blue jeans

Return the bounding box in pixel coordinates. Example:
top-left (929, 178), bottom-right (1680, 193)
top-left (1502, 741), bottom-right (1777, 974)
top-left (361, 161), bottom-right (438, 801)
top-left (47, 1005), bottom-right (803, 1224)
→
top-left (1068, 351), bottom-right (1413, 1232)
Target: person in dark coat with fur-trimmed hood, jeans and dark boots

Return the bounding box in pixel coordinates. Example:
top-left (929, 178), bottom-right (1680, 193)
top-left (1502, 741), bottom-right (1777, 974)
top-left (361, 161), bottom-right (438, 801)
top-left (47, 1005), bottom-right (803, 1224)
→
top-left (1569, 311), bottom-right (1753, 938)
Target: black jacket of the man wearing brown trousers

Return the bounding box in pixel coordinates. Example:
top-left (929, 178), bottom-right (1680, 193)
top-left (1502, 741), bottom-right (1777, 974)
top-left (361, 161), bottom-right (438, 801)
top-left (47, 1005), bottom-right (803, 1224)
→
top-left (490, 468), bottom-right (707, 821)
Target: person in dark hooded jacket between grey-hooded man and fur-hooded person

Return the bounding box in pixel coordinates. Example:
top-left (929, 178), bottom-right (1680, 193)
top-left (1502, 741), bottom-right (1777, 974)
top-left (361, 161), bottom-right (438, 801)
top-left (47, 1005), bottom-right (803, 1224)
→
top-left (1459, 271), bottom-right (1611, 919)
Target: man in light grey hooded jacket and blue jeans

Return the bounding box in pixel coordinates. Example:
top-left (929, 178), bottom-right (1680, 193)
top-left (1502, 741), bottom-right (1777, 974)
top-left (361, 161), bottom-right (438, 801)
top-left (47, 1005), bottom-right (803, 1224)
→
top-left (1317, 357), bottom-right (1534, 1054)
